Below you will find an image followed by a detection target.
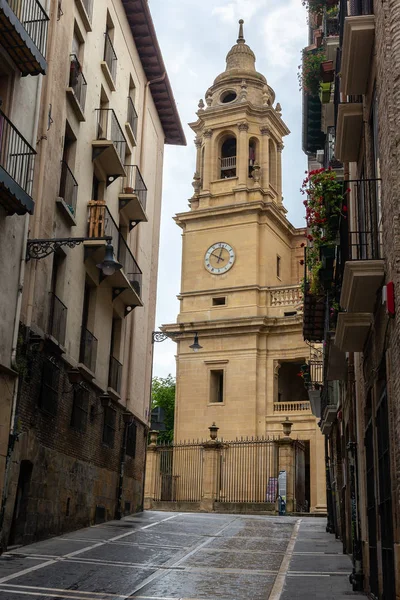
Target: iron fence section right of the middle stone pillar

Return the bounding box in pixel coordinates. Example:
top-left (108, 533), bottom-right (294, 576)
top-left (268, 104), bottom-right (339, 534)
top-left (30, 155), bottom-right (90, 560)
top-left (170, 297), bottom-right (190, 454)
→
top-left (216, 437), bottom-right (278, 503)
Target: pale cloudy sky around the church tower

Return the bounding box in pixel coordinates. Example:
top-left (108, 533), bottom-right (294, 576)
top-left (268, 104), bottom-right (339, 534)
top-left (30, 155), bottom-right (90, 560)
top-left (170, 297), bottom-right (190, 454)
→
top-left (149, 0), bottom-right (307, 377)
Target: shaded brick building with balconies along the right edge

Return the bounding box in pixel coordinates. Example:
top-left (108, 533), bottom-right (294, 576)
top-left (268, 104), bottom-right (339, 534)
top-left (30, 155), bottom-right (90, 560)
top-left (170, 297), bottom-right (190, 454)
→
top-left (304, 0), bottom-right (400, 599)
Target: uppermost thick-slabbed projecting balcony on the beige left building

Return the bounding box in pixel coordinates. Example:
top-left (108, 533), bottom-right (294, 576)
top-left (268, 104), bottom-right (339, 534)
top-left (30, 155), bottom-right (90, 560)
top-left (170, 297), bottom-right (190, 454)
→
top-left (92, 108), bottom-right (126, 185)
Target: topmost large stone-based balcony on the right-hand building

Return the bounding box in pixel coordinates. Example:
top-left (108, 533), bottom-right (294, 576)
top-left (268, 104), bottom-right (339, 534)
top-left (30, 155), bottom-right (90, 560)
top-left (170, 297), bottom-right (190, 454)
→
top-left (340, 0), bottom-right (375, 96)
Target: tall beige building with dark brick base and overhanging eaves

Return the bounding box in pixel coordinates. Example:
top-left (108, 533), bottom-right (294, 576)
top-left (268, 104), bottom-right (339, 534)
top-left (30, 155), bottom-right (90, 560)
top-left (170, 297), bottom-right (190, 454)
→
top-left (2, 0), bottom-right (185, 545)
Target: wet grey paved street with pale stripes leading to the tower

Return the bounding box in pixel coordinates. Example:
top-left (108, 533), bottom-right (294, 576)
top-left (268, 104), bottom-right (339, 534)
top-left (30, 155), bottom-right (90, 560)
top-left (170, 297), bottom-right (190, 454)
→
top-left (0, 512), bottom-right (365, 600)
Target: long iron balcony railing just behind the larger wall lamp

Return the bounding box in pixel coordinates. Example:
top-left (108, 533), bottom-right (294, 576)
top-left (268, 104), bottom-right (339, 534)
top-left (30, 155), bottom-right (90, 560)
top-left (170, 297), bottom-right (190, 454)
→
top-left (89, 204), bottom-right (142, 297)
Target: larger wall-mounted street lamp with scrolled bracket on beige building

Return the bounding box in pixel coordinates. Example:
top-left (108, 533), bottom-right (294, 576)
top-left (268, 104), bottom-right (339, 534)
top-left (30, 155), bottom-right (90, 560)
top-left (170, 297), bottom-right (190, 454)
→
top-left (25, 236), bottom-right (122, 276)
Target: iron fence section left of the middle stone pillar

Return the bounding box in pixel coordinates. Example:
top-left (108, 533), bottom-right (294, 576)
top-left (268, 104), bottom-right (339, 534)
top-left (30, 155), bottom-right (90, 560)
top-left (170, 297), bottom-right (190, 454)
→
top-left (155, 443), bottom-right (203, 502)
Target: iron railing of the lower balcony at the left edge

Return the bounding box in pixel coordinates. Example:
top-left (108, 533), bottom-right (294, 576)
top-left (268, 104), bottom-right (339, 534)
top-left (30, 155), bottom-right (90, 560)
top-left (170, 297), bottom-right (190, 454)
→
top-left (0, 110), bottom-right (36, 196)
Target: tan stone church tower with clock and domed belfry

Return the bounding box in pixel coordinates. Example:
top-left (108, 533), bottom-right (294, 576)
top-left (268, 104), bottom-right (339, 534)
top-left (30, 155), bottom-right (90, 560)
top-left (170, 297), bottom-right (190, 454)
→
top-left (163, 20), bottom-right (326, 512)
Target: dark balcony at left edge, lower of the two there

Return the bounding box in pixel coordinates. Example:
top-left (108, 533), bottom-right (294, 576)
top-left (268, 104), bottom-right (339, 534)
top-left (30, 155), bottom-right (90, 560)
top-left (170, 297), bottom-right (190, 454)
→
top-left (0, 110), bottom-right (36, 215)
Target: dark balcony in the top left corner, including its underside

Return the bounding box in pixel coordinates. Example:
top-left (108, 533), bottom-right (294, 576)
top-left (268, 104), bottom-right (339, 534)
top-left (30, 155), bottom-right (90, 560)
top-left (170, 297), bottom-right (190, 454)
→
top-left (0, 0), bottom-right (49, 76)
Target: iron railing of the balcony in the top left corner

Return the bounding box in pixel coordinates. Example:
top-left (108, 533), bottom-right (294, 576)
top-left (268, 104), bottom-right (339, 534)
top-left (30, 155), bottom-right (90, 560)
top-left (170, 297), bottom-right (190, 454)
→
top-left (6, 0), bottom-right (49, 57)
